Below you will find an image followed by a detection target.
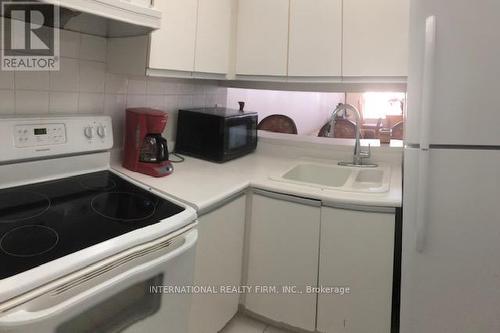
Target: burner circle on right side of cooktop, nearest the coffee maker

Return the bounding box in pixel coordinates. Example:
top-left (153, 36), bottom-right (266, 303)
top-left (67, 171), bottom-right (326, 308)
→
top-left (91, 192), bottom-right (156, 222)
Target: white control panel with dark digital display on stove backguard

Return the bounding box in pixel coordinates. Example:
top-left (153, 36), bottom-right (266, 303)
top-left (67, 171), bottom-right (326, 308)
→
top-left (14, 124), bottom-right (66, 148)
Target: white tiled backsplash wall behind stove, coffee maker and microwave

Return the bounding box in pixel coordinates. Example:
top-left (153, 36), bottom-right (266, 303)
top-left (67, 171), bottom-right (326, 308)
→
top-left (0, 26), bottom-right (227, 147)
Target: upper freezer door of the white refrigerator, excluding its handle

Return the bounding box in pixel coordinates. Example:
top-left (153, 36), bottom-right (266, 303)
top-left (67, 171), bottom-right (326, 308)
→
top-left (405, 0), bottom-right (500, 145)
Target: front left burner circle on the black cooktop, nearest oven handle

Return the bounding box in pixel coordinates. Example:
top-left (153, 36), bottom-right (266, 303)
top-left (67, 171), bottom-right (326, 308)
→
top-left (0, 225), bottom-right (59, 258)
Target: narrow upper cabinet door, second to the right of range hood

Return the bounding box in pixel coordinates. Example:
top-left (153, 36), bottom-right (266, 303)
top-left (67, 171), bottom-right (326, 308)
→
top-left (194, 0), bottom-right (234, 74)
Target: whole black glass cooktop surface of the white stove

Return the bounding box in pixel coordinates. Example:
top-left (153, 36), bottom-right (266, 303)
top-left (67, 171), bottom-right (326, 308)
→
top-left (0, 171), bottom-right (184, 279)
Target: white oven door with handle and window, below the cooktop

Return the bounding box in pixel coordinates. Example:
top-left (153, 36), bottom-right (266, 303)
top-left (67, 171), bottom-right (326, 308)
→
top-left (0, 226), bottom-right (198, 333)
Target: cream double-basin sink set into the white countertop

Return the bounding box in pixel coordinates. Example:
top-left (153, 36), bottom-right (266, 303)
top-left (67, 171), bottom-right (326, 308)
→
top-left (271, 161), bottom-right (391, 193)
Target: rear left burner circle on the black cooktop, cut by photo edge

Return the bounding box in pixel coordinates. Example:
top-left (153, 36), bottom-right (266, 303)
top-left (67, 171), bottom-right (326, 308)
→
top-left (0, 191), bottom-right (50, 223)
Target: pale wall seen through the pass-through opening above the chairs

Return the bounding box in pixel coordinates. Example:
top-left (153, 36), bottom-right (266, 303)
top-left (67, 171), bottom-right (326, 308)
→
top-left (227, 88), bottom-right (345, 136)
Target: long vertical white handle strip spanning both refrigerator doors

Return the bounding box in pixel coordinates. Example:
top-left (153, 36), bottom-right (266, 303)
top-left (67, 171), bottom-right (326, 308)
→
top-left (416, 16), bottom-right (436, 252)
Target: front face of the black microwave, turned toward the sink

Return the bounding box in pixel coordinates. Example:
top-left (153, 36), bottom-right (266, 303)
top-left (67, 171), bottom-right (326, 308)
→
top-left (223, 115), bottom-right (257, 161)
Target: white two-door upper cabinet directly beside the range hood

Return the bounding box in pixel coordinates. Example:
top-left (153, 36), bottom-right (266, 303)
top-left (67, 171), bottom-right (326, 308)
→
top-left (148, 0), bottom-right (234, 74)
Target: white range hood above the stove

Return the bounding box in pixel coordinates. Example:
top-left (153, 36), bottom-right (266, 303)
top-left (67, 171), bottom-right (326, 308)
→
top-left (22, 0), bottom-right (161, 37)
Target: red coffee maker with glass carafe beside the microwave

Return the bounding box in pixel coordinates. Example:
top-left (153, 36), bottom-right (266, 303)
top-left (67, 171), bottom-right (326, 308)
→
top-left (123, 108), bottom-right (174, 177)
